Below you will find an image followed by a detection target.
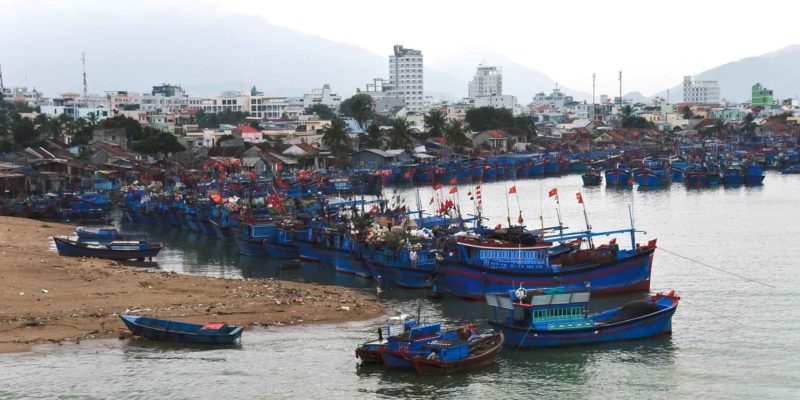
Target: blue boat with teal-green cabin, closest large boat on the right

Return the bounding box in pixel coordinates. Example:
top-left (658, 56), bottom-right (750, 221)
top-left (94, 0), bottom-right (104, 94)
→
top-left (486, 287), bottom-right (680, 348)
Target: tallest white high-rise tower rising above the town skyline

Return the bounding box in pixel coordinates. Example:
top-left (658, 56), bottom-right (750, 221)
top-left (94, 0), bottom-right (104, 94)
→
top-left (389, 45), bottom-right (426, 114)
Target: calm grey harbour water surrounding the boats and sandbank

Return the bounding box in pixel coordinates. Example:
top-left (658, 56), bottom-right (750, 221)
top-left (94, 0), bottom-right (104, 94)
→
top-left (0, 173), bottom-right (800, 399)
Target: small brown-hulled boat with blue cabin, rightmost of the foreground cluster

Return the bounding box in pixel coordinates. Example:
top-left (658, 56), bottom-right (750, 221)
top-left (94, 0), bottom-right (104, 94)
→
top-left (412, 332), bottom-right (504, 375)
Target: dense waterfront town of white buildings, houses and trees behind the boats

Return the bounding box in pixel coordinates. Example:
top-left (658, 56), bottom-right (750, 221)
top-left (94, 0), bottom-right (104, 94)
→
top-left (0, 45), bottom-right (800, 196)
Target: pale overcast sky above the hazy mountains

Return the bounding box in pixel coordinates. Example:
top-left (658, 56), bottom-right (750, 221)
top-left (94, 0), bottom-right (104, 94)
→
top-left (6, 0), bottom-right (800, 95)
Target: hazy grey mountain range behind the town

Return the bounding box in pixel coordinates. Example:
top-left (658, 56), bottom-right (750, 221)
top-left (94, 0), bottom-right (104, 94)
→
top-left (0, 7), bottom-right (800, 104)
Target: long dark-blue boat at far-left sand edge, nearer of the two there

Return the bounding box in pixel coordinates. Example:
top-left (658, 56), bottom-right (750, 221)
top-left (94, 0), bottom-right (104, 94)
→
top-left (53, 236), bottom-right (162, 260)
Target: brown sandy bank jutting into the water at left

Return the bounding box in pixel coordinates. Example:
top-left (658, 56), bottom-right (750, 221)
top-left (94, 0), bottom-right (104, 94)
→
top-left (0, 217), bottom-right (385, 353)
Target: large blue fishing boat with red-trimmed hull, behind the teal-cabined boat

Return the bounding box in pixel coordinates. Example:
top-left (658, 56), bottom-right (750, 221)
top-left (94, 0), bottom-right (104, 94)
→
top-left (435, 229), bottom-right (656, 298)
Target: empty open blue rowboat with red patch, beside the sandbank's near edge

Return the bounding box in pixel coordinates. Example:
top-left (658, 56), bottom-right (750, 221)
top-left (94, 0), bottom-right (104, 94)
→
top-left (119, 314), bottom-right (244, 345)
